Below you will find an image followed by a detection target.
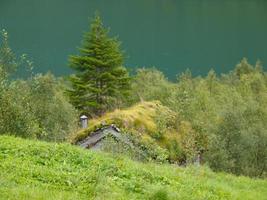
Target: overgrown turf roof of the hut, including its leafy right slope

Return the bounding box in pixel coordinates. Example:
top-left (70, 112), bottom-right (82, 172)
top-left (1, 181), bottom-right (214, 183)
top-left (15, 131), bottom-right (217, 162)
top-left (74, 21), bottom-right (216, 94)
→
top-left (70, 101), bottom-right (177, 162)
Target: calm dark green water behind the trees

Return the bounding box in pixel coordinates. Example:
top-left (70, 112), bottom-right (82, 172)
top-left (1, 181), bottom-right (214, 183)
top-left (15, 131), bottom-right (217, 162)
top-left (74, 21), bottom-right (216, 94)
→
top-left (0, 0), bottom-right (267, 78)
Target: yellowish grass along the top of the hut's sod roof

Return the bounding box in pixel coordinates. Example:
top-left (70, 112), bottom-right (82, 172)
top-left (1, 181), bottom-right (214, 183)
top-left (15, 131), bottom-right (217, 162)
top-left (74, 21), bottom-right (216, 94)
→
top-left (70, 101), bottom-right (175, 143)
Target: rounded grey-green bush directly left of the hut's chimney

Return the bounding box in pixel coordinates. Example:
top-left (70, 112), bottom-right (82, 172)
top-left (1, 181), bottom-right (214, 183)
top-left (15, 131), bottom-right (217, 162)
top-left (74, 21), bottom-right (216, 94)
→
top-left (27, 73), bottom-right (78, 141)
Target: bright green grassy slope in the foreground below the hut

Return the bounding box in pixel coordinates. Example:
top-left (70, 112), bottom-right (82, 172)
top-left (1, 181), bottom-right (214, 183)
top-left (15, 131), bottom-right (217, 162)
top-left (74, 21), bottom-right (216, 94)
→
top-left (0, 136), bottom-right (267, 200)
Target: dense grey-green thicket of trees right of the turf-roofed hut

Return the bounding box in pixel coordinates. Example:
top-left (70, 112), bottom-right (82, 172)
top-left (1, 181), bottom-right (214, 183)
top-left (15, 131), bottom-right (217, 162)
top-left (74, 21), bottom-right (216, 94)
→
top-left (127, 58), bottom-right (267, 177)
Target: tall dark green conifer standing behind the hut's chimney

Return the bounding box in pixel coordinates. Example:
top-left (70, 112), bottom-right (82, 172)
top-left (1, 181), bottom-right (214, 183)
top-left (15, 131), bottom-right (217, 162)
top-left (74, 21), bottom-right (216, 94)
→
top-left (68, 15), bottom-right (130, 116)
